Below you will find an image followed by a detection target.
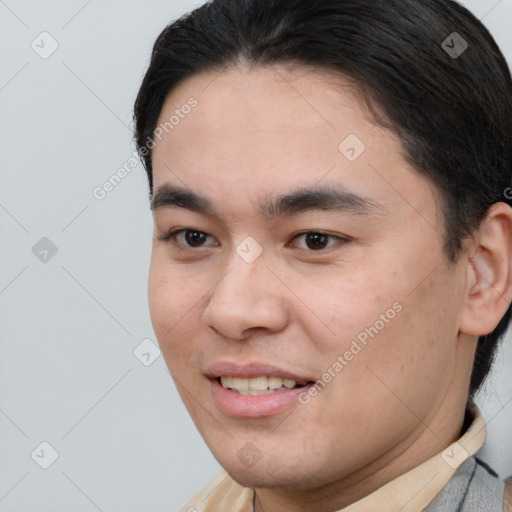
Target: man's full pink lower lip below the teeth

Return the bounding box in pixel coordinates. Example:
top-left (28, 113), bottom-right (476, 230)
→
top-left (210, 379), bottom-right (313, 418)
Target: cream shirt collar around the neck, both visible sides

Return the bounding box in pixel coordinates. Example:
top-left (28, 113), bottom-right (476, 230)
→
top-left (180, 401), bottom-right (487, 512)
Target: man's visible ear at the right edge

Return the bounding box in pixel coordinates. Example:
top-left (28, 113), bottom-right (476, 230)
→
top-left (459, 202), bottom-right (512, 336)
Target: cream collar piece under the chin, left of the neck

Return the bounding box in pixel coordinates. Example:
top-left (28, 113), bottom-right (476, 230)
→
top-left (179, 471), bottom-right (254, 512)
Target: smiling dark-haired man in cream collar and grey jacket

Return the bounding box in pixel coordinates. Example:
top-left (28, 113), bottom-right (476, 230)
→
top-left (135, 0), bottom-right (512, 512)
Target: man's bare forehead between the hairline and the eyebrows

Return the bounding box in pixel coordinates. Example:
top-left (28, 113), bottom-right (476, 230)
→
top-left (153, 62), bottom-right (435, 224)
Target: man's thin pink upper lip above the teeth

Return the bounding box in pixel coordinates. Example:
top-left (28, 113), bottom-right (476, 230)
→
top-left (205, 361), bottom-right (316, 384)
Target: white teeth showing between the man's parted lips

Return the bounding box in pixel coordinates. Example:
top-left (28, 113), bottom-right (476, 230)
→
top-left (216, 375), bottom-right (313, 396)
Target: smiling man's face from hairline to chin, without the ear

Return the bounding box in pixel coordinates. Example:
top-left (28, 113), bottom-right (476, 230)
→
top-left (149, 66), bottom-right (467, 489)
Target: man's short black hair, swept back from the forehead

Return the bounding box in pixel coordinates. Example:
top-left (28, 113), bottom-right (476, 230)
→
top-left (134, 0), bottom-right (512, 398)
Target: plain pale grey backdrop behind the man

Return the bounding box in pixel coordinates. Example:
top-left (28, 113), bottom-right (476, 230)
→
top-left (0, 0), bottom-right (512, 512)
